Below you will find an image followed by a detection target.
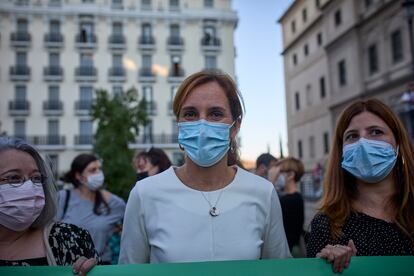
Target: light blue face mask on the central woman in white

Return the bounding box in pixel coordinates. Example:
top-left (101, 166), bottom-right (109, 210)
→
top-left (178, 119), bottom-right (234, 167)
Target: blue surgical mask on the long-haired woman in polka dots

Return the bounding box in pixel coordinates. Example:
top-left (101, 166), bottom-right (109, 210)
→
top-left (342, 138), bottom-right (398, 183)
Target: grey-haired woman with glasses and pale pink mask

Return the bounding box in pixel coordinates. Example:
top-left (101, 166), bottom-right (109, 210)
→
top-left (0, 136), bottom-right (99, 275)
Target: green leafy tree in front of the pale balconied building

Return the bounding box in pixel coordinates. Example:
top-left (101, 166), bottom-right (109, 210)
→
top-left (92, 88), bottom-right (148, 200)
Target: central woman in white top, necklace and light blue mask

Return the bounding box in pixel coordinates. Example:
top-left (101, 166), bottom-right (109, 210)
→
top-left (119, 71), bottom-right (291, 264)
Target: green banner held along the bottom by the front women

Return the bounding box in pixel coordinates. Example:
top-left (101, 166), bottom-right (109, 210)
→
top-left (0, 256), bottom-right (414, 276)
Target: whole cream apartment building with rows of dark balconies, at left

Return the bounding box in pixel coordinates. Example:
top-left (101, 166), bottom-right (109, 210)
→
top-left (0, 0), bottom-right (237, 176)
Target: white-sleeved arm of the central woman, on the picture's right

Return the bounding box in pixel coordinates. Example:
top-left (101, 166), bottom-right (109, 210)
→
top-left (262, 189), bottom-right (292, 259)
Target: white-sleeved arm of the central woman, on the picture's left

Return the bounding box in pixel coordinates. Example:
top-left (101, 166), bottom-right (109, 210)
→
top-left (118, 187), bottom-right (150, 264)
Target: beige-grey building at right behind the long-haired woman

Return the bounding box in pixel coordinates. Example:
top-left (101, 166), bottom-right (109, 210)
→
top-left (279, 0), bottom-right (414, 170)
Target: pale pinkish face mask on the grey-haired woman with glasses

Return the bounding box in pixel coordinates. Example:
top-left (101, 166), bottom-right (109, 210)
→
top-left (0, 180), bottom-right (45, 231)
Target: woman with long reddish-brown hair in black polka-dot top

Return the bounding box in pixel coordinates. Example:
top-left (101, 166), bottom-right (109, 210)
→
top-left (307, 99), bottom-right (414, 272)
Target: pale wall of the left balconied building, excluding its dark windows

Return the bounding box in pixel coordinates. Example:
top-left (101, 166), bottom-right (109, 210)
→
top-left (0, 0), bottom-right (237, 176)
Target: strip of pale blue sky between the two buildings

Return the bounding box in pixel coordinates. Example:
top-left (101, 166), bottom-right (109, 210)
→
top-left (233, 0), bottom-right (293, 161)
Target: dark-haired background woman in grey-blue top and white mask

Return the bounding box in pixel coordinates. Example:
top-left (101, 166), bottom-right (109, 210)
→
top-left (57, 154), bottom-right (125, 264)
